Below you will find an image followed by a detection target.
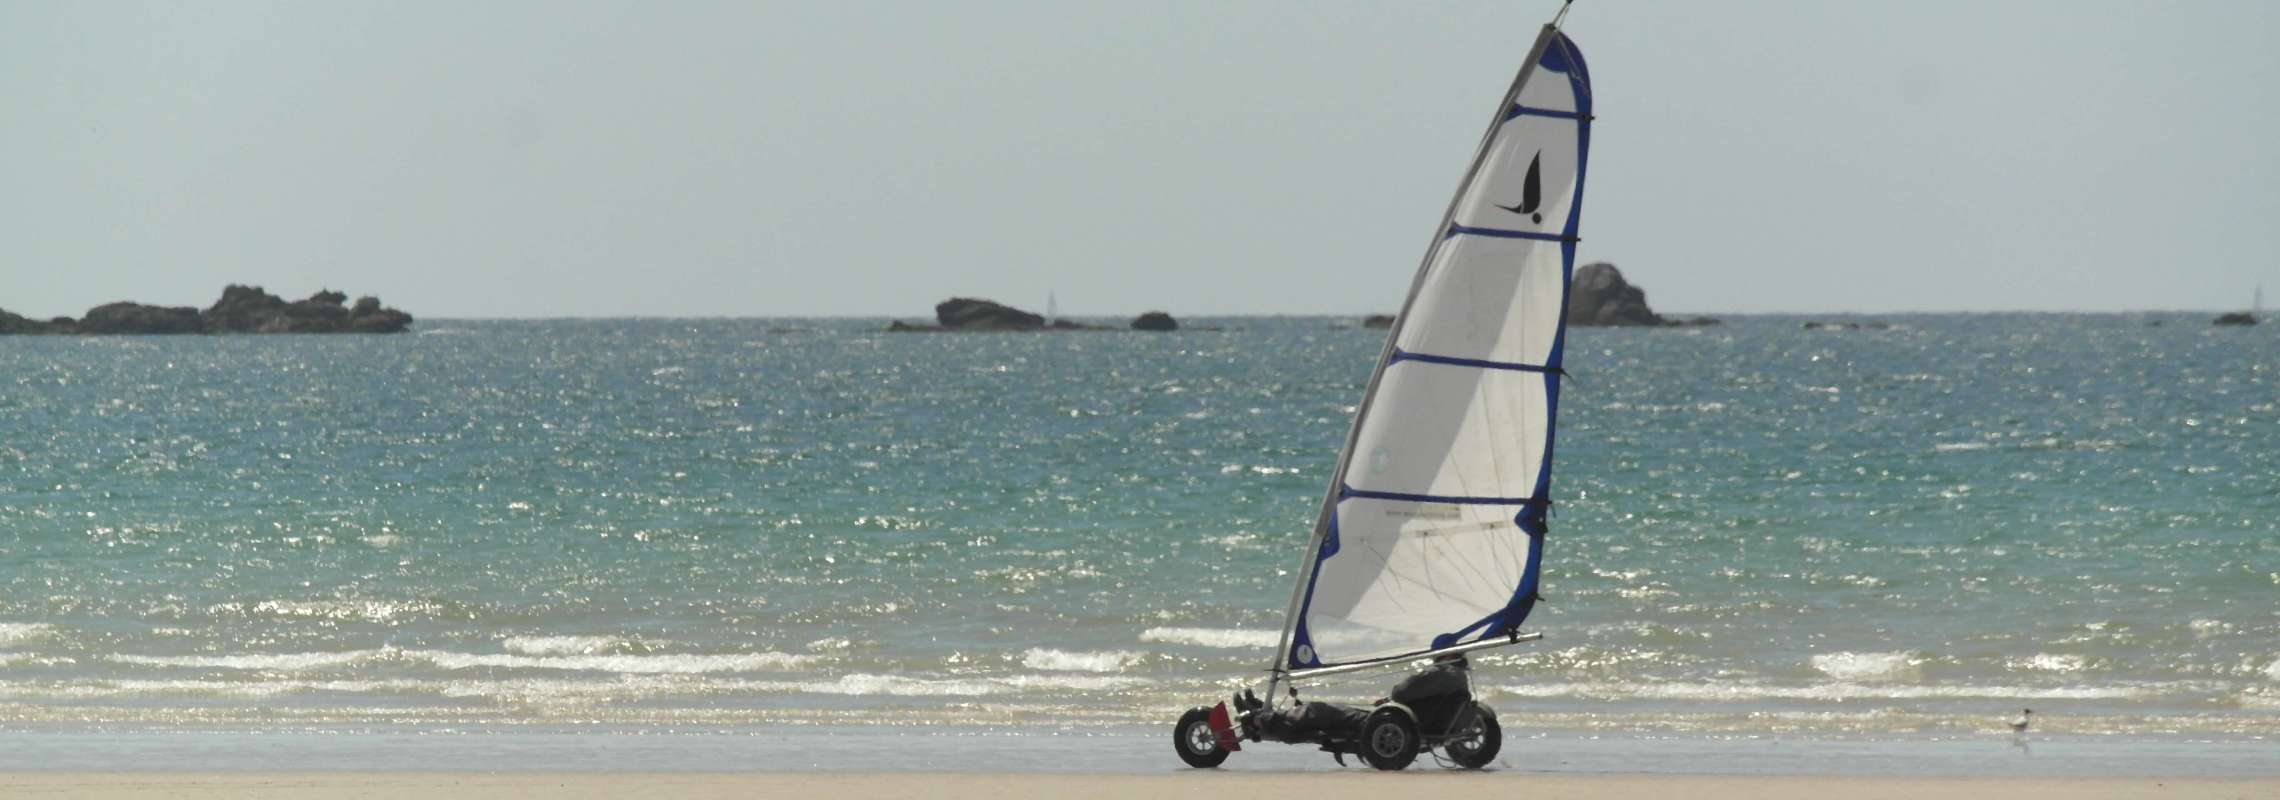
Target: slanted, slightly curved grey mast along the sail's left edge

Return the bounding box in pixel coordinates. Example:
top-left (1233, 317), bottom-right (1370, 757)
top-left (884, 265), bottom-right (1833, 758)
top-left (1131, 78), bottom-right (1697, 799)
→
top-left (1268, 20), bottom-right (1566, 704)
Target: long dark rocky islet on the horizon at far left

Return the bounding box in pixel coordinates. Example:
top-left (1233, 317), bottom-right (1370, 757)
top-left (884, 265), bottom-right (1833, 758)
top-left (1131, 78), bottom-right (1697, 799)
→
top-left (0, 285), bottom-right (413, 335)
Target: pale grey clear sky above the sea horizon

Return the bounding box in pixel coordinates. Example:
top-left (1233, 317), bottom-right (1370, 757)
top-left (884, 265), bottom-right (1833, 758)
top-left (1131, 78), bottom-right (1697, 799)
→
top-left (0, 0), bottom-right (2280, 319)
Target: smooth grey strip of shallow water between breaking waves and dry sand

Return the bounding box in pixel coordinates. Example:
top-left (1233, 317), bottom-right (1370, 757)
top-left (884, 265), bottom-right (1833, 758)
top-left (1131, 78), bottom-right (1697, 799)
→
top-left (0, 725), bottom-right (2280, 779)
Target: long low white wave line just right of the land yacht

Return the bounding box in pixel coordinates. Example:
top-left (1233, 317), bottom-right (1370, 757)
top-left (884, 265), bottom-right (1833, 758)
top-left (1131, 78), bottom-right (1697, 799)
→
top-left (1491, 681), bottom-right (2175, 702)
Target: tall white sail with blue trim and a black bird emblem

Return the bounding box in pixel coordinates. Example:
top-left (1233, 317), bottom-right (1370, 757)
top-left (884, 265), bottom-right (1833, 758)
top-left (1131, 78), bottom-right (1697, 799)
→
top-left (1277, 25), bottom-right (1591, 670)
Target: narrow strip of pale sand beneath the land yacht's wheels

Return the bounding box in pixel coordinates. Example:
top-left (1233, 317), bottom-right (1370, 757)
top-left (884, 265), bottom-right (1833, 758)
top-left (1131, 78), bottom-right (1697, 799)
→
top-left (0, 770), bottom-right (2280, 800)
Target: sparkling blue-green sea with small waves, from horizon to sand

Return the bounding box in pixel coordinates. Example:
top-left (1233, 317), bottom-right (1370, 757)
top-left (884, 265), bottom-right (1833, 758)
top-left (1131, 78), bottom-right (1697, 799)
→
top-left (0, 312), bottom-right (2280, 775)
